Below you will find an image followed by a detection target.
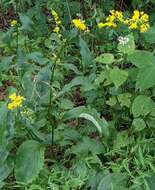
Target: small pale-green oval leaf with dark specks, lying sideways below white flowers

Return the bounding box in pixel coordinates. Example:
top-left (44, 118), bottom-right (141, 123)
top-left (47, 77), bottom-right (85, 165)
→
top-left (95, 53), bottom-right (114, 64)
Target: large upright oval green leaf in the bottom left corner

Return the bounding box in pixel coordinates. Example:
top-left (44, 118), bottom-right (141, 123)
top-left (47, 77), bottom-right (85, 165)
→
top-left (15, 140), bottom-right (44, 183)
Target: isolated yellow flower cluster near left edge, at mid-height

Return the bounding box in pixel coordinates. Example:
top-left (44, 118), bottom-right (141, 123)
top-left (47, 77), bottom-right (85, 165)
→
top-left (7, 93), bottom-right (25, 110)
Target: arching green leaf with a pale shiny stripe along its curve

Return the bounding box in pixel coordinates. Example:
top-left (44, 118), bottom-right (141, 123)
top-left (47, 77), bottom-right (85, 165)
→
top-left (63, 106), bottom-right (109, 136)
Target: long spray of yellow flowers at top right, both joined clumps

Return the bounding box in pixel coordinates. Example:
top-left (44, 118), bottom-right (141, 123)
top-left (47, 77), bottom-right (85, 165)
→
top-left (98, 10), bottom-right (149, 32)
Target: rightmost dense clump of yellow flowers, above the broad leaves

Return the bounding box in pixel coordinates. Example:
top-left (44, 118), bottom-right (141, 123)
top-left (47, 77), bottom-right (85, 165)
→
top-left (128, 10), bottom-right (150, 32)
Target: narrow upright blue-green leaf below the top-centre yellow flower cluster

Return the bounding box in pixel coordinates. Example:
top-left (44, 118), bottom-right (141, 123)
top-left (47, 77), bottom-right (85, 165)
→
top-left (79, 37), bottom-right (92, 68)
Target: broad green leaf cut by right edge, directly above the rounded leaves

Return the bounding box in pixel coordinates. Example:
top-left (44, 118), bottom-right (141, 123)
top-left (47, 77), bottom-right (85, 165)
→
top-left (136, 64), bottom-right (155, 91)
